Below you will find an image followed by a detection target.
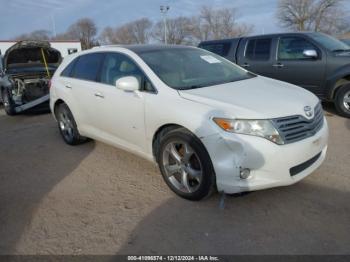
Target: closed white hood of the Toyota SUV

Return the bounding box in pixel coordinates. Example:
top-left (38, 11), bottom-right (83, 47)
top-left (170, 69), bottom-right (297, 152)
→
top-left (179, 76), bottom-right (319, 119)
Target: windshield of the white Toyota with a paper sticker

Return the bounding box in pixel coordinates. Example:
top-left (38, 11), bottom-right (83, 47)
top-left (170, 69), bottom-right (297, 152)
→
top-left (139, 47), bottom-right (254, 90)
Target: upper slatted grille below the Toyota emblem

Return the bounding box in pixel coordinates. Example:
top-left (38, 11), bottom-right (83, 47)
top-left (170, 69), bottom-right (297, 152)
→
top-left (272, 103), bottom-right (324, 144)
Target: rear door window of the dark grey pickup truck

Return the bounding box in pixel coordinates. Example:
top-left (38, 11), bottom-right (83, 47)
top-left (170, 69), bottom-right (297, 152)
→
top-left (245, 38), bottom-right (272, 60)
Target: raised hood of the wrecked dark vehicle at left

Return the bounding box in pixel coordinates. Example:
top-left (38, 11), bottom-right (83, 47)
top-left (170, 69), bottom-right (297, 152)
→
top-left (4, 41), bottom-right (62, 69)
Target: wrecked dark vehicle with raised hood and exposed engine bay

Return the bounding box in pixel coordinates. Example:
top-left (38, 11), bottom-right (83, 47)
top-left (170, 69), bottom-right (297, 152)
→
top-left (0, 41), bottom-right (62, 115)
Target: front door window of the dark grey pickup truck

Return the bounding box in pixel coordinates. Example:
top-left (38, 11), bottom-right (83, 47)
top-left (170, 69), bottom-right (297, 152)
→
top-left (277, 36), bottom-right (316, 60)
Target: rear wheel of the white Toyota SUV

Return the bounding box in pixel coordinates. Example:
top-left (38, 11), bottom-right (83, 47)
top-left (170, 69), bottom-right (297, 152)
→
top-left (55, 104), bottom-right (87, 145)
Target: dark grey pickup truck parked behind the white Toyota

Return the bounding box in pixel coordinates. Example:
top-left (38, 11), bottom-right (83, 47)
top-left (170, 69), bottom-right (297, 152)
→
top-left (199, 32), bottom-right (350, 117)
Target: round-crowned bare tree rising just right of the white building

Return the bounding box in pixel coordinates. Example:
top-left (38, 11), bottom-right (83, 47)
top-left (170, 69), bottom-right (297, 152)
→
top-left (65, 18), bottom-right (97, 49)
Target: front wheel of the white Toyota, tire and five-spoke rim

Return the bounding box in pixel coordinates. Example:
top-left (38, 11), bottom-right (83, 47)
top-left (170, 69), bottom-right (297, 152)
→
top-left (157, 128), bottom-right (215, 200)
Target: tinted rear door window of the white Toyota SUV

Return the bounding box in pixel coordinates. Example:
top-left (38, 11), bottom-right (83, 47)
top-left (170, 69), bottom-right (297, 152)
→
top-left (73, 53), bottom-right (104, 81)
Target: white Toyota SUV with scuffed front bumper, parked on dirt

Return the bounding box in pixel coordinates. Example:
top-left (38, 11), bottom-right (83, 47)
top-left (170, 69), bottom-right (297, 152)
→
top-left (50, 45), bottom-right (328, 200)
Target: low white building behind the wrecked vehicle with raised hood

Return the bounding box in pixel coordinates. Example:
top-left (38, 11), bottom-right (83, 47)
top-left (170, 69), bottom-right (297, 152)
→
top-left (0, 40), bottom-right (81, 57)
